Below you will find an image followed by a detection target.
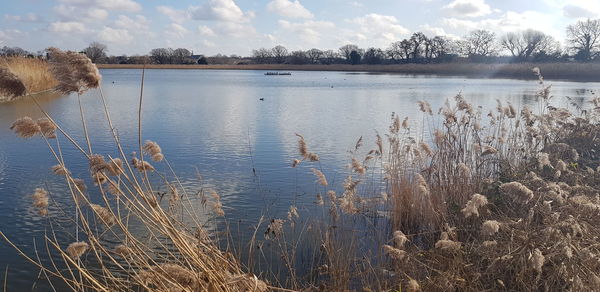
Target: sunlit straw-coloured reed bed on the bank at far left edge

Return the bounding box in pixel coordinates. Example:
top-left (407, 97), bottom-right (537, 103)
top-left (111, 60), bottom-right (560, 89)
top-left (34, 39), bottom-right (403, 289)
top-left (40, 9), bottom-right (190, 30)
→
top-left (0, 57), bottom-right (58, 102)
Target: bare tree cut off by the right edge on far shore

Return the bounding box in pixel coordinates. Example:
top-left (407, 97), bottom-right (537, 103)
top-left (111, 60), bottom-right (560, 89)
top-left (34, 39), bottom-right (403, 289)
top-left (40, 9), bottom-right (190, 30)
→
top-left (567, 19), bottom-right (600, 61)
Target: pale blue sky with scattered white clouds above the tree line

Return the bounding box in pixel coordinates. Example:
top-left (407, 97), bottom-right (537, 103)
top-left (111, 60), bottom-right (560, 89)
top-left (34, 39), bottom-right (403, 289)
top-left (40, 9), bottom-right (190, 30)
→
top-left (0, 0), bottom-right (600, 56)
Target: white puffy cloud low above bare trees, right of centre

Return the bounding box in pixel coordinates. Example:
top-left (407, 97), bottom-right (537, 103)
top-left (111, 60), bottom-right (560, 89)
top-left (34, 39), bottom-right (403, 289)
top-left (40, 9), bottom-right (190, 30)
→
top-left (350, 13), bottom-right (410, 46)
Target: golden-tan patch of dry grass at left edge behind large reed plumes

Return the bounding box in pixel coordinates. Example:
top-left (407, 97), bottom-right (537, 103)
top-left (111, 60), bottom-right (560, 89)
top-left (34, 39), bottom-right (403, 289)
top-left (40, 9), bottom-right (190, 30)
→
top-left (0, 57), bottom-right (58, 98)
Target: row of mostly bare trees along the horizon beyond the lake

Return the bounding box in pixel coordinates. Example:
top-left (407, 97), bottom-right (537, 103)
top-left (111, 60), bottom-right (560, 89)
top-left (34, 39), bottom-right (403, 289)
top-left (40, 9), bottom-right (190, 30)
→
top-left (0, 19), bottom-right (600, 65)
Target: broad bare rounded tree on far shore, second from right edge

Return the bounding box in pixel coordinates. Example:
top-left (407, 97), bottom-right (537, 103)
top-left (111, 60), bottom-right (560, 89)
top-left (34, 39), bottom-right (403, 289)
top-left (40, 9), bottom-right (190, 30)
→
top-left (500, 29), bottom-right (558, 60)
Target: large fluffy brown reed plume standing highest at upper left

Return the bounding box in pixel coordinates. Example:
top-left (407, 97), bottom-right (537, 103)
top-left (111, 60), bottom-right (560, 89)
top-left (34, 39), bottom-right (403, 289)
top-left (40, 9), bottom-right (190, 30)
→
top-left (48, 48), bottom-right (102, 94)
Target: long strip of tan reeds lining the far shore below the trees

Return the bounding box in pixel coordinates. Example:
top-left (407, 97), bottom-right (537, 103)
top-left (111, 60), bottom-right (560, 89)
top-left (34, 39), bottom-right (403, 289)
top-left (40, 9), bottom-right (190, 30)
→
top-left (97, 63), bottom-right (600, 82)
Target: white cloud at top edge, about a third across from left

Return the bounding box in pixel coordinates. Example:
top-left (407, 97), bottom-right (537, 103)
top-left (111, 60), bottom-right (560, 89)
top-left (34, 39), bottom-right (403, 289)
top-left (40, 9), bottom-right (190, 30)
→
top-left (190, 0), bottom-right (254, 23)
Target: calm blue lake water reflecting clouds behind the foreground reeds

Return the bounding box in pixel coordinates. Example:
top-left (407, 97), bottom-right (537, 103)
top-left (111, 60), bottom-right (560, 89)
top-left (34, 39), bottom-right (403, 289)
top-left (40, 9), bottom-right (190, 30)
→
top-left (0, 70), bottom-right (600, 291)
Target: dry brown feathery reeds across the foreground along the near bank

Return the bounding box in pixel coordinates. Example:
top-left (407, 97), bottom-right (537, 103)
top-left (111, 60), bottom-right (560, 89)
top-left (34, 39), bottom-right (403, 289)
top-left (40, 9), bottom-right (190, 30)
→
top-left (2, 50), bottom-right (600, 291)
